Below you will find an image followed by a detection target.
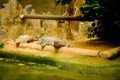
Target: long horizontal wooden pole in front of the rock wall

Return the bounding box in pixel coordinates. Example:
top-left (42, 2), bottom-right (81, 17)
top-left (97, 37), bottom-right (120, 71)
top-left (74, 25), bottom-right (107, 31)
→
top-left (20, 14), bottom-right (89, 21)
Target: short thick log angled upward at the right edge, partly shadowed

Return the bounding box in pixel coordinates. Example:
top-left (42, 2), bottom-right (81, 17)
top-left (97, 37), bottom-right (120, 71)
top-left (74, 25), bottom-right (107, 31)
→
top-left (99, 47), bottom-right (120, 59)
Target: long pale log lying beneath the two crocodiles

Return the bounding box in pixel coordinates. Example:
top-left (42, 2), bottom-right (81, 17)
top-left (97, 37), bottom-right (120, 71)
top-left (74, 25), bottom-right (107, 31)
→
top-left (19, 43), bottom-right (100, 57)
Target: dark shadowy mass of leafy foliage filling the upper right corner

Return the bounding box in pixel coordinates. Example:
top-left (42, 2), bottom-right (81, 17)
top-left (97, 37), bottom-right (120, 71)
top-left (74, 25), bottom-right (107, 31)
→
top-left (80, 0), bottom-right (120, 40)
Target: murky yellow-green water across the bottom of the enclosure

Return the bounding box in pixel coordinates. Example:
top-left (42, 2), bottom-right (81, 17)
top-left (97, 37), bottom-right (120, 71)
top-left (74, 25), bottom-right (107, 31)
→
top-left (0, 58), bottom-right (120, 80)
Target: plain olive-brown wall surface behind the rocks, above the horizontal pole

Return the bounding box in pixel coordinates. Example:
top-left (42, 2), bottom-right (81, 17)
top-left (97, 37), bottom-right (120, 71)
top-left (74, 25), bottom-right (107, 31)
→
top-left (0, 0), bottom-right (61, 14)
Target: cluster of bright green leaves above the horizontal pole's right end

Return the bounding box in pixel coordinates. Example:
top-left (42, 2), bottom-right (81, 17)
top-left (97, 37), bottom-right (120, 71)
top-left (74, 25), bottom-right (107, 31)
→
top-left (80, 0), bottom-right (103, 19)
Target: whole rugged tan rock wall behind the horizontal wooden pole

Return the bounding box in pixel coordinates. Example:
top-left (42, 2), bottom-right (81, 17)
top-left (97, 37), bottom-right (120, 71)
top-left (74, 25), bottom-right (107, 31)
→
top-left (0, 0), bottom-right (88, 40)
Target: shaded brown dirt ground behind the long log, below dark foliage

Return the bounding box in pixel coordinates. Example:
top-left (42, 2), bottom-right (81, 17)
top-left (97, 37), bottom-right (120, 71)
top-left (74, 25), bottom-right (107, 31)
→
top-left (72, 39), bottom-right (120, 51)
